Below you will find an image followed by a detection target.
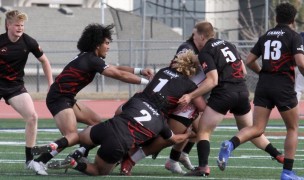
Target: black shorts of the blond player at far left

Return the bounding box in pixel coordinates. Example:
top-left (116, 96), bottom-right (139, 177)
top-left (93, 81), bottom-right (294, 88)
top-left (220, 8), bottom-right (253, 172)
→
top-left (0, 84), bottom-right (27, 105)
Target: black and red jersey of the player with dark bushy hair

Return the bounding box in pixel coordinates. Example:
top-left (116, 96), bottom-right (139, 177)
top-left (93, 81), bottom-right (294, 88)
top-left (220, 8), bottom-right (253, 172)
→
top-left (49, 52), bottom-right (109, 97)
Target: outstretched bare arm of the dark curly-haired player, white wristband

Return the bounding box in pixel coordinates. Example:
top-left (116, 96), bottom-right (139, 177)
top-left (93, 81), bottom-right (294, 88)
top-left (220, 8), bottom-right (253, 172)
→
top-left (101, 65), bottom-right (149, 84)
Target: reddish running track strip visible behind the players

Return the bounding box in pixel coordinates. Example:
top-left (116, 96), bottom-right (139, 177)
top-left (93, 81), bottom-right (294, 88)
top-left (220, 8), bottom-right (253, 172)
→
top-left (0, 100), bottom-right (304, 119)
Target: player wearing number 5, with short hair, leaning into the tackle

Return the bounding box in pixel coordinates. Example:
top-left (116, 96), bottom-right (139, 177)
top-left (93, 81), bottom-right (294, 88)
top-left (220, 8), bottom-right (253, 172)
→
top-left (179, 22), bottom-right (280, 176)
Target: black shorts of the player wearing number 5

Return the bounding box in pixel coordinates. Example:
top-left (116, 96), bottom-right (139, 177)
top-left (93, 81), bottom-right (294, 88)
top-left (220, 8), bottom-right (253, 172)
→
top-left (207, 91), bottom-right (251, 116)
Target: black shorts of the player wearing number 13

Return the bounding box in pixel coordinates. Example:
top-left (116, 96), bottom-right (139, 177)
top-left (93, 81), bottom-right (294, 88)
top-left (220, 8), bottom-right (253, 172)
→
top-left (253, 87), bottom-right (298, 112)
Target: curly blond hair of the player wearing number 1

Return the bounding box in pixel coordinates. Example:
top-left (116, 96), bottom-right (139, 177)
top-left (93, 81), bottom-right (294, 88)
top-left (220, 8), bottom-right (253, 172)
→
top-left (171, 49), bottom-right (198, 77)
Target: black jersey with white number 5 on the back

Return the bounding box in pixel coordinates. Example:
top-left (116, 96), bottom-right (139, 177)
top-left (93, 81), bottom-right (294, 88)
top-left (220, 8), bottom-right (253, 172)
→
top-left (198, 38), bottom-right (245, 91)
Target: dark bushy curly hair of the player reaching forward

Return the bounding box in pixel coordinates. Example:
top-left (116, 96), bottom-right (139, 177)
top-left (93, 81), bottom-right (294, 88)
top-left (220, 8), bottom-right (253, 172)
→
top-left (77, 23), bottom-right (114, 52)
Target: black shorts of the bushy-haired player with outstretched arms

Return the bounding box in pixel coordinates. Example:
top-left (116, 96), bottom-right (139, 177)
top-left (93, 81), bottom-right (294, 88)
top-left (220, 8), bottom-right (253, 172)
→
top-left (46, 94), bottom-right (76, 116)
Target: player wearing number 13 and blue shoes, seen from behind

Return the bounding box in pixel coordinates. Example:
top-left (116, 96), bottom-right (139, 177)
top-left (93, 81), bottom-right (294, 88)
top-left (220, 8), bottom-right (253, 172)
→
top-left (219, 3), bottom-right (304, 180)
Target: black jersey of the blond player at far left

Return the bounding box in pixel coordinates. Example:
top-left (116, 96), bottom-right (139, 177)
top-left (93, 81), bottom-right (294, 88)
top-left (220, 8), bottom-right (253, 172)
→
top-left (0, 33), bottom-right (43, 86)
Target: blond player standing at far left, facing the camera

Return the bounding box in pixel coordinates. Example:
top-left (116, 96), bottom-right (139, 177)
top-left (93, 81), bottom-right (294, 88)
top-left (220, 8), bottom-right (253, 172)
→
top-left (0, 10), bottom-right (53, 175)
